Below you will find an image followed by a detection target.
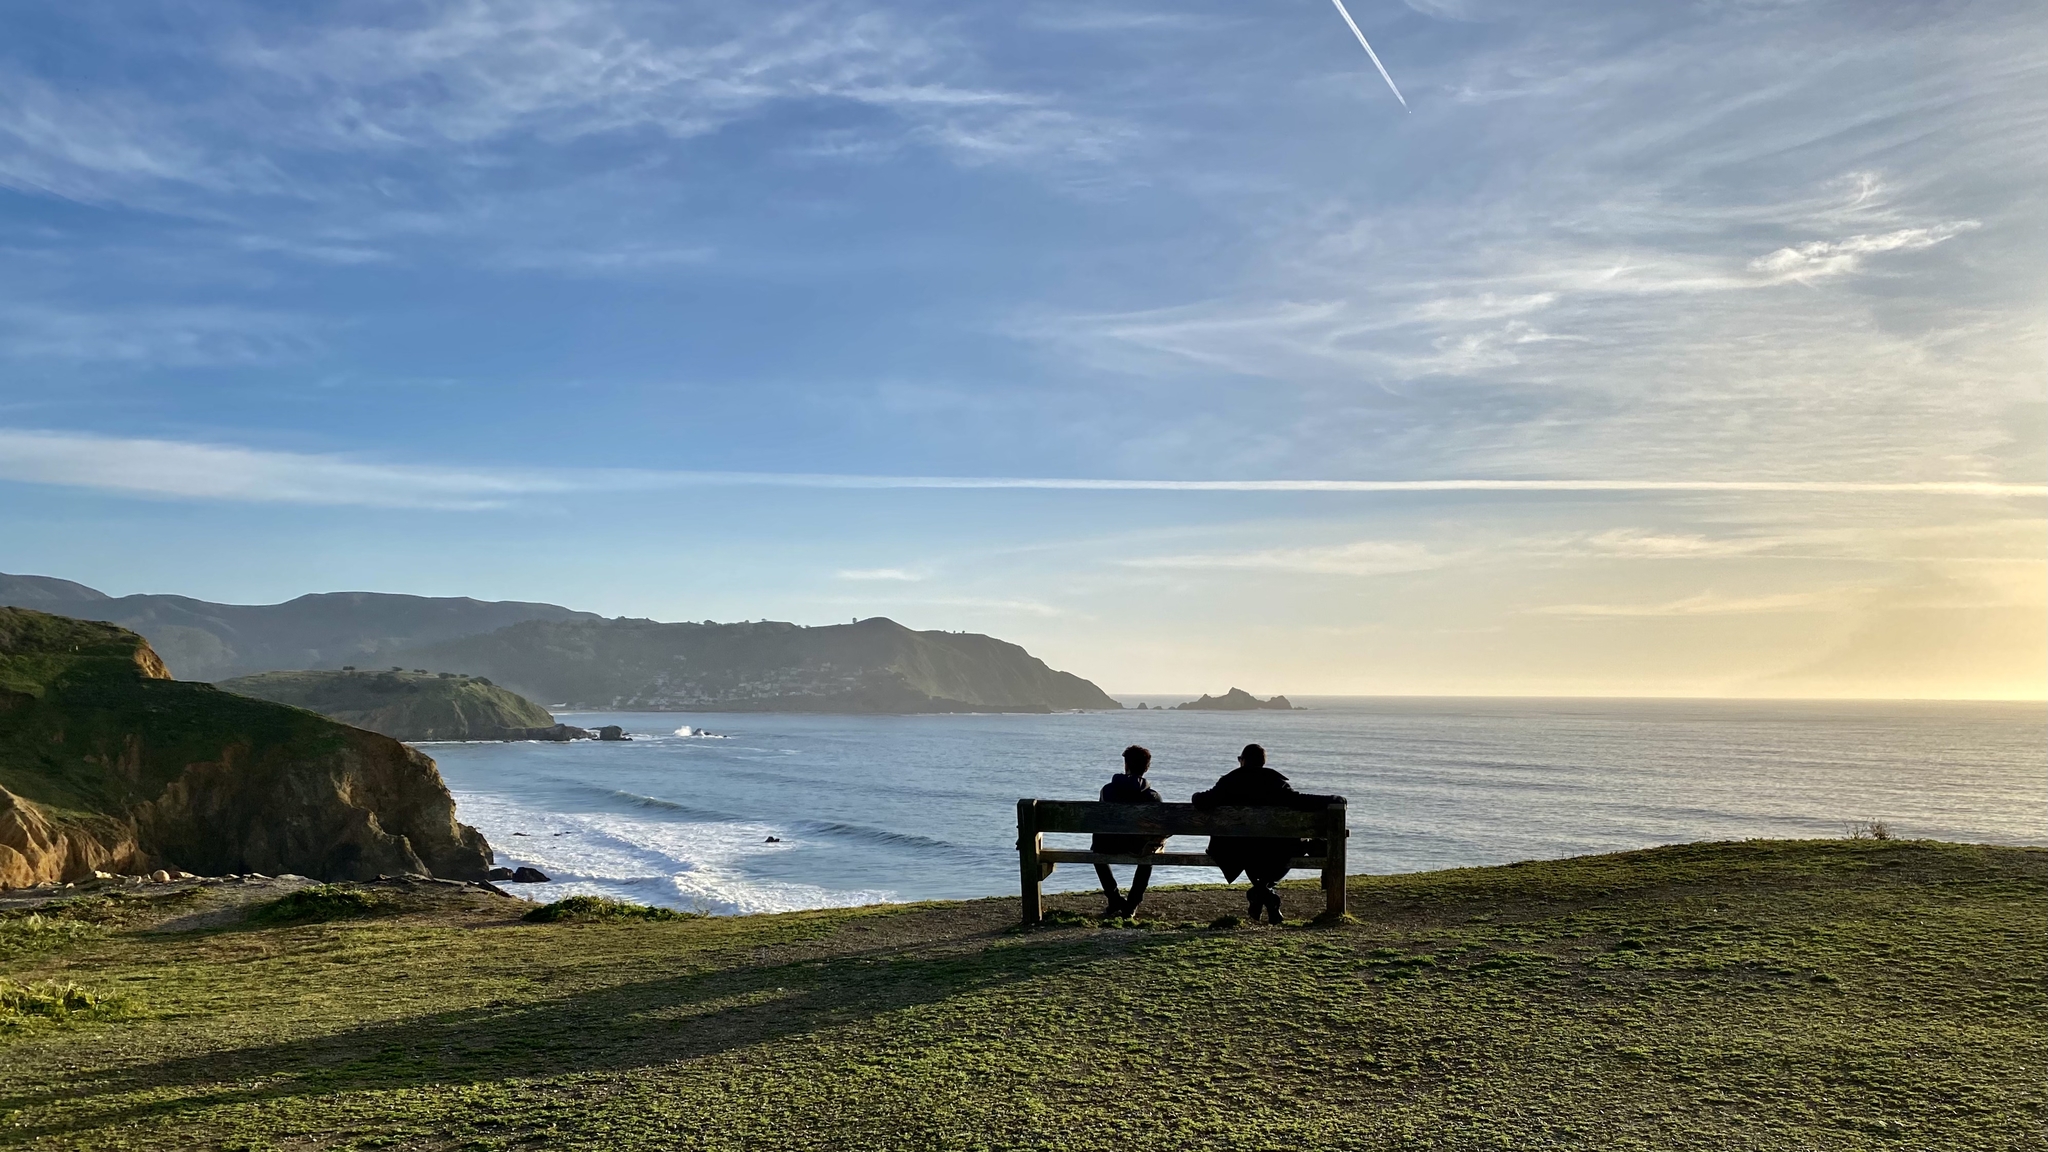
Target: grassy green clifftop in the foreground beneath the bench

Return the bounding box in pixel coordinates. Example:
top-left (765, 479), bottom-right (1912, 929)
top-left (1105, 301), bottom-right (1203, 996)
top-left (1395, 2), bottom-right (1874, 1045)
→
top-left (0, 840), bottom-right (2048, 1152)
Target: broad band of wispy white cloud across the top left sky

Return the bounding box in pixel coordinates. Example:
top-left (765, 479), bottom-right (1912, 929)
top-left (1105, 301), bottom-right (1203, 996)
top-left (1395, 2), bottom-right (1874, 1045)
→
top-left (0, 0), bottom-right (1135, 211)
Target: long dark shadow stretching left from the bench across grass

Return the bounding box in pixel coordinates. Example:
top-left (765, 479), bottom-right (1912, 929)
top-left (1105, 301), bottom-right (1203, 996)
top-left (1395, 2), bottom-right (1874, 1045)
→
top-left (0, 922), bottom-right (1163, 1142)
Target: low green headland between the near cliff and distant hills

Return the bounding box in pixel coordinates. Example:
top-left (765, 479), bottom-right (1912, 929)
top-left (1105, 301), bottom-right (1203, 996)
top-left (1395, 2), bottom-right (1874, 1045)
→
top-left (219, 670), bottom-right (555, 740)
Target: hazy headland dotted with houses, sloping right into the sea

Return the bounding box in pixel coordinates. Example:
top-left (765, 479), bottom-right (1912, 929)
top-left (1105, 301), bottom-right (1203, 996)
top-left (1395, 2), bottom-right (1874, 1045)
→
top-left (406, 617), bottom-right (1122, 711)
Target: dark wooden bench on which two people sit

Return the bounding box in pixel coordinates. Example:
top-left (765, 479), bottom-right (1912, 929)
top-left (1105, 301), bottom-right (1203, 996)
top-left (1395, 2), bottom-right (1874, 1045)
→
top-left (1018, 799), bottom-right (1350, 924)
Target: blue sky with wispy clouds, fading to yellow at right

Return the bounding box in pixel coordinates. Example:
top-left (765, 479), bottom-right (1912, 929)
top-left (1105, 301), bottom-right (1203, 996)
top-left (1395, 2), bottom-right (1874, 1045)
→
top-left (0, 0), bottom-right (2048, 699)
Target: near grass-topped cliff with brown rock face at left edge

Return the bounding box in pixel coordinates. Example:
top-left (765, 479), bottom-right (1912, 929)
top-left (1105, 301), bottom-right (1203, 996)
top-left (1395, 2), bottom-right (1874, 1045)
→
top-left (0, 609), bottom-right (492, 886)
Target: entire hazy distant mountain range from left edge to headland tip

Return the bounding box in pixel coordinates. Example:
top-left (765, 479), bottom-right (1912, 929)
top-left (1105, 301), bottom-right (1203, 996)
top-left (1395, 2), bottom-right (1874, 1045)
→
top-left (0, 574), bottom-right (1122, 724)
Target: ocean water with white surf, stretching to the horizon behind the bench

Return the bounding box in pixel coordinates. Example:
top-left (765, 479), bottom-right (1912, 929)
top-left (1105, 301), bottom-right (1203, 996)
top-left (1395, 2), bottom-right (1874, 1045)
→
top-left (426, 697), bottom-right (2048, 912)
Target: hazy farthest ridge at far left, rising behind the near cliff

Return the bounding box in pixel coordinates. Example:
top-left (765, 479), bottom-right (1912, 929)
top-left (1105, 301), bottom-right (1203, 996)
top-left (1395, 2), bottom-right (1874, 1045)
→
top-left (0, 574), bottom-right (598, 681)
